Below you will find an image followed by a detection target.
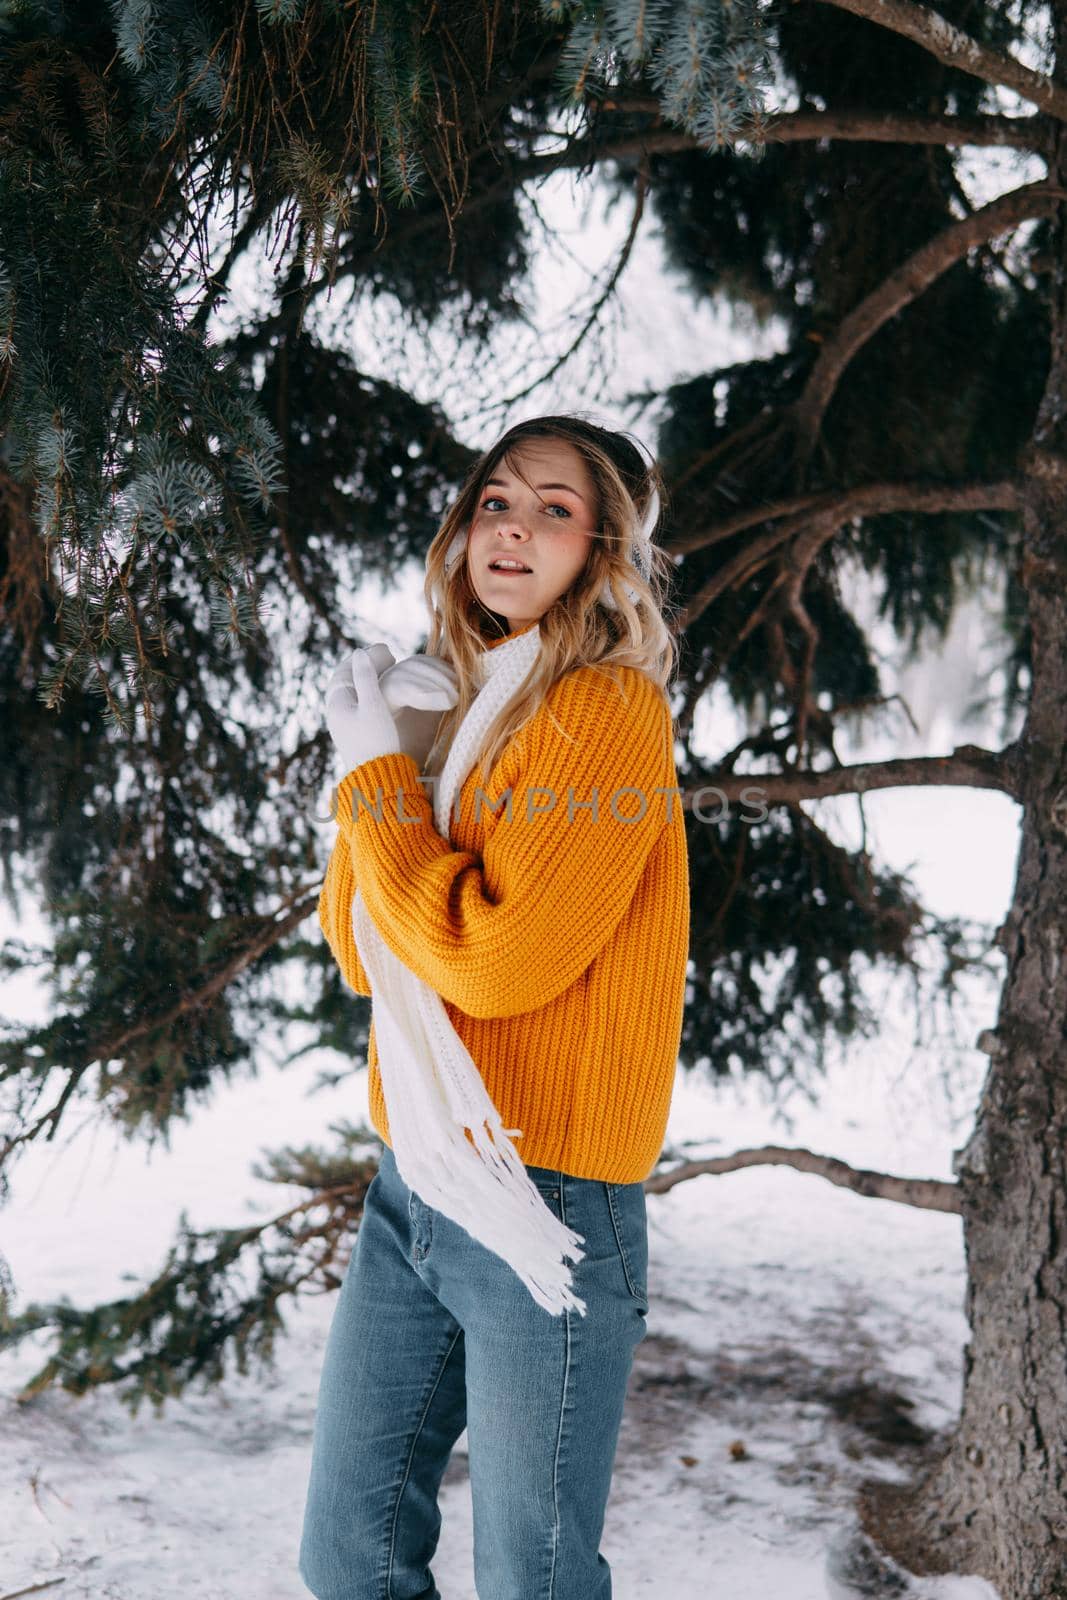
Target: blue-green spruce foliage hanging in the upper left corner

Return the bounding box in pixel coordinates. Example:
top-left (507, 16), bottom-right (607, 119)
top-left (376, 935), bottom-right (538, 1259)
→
top-left (0, 0), bottom-right (563, 720)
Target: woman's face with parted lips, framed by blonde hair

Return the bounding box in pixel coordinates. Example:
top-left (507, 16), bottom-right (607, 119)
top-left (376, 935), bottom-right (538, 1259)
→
top-left (467, 438), bottom-right (600, 632)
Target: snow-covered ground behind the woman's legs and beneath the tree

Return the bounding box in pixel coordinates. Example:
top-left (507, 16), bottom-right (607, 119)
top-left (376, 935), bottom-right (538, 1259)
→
top-left (0, 1011), bottom-right (992, 1600)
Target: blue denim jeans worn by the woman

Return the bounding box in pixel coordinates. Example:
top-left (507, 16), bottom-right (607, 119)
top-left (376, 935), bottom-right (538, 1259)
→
top-left (299, 1146), bottom-right (648, 1600)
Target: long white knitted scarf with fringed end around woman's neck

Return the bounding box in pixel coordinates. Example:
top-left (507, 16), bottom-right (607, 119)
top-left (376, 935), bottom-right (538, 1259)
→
top-left (352, 626), bottom-right (585, 1315)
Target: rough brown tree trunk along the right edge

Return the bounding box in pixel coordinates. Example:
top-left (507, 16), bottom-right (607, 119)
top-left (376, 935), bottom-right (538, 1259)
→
top-left (861, 34), bottom-right (1067, 1600)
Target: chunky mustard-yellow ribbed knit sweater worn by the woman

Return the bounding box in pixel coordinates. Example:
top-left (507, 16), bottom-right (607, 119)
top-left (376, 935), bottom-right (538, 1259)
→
top-left (318, 624), bottom-right (689, 1184)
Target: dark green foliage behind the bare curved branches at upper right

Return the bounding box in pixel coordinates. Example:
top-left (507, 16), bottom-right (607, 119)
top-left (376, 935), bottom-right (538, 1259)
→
top-left (630, 8), bottom-right (1049, 730)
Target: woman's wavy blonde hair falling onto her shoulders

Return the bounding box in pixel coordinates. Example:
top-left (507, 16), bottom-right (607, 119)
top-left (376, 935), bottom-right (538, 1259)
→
top-left (424, 414), bottom-right (678, 778)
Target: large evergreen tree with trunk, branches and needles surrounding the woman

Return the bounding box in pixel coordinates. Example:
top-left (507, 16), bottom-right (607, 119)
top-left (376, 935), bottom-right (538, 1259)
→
top-left (0, 0), bottom-right (1067, 1600)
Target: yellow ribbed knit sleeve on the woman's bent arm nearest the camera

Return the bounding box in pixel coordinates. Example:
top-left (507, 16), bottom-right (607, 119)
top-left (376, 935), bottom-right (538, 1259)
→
top-left (338, 667), bottom-right (677, 1018)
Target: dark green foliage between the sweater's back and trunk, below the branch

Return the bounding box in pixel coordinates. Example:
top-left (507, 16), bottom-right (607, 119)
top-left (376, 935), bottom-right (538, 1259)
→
top-left (681, 800), bottom-right (1001, 1099)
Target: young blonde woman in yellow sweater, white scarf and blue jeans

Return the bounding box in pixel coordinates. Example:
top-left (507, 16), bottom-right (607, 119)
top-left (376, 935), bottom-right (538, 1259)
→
top-left (299, 416), bottom-right (689, 1600)
